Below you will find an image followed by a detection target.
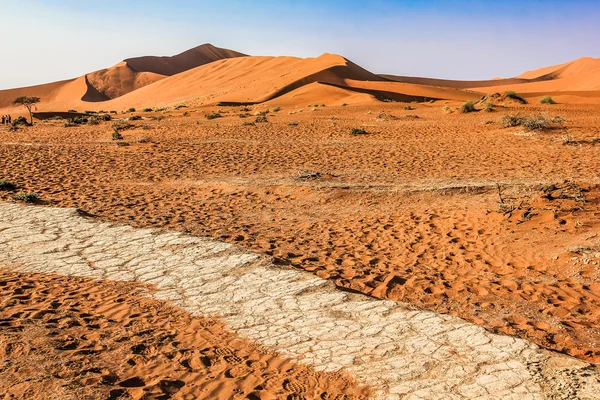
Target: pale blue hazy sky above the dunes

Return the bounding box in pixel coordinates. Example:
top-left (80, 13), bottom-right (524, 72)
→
top-left (0, 0), bottom-right (600, 89)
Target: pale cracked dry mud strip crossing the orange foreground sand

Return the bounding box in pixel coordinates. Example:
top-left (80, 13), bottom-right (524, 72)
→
top-left (0, 203), bottom-right (600, 399)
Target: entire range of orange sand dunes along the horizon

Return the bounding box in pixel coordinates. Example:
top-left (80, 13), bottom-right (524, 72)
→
top-left (0, 49), bottom-right (600, 111)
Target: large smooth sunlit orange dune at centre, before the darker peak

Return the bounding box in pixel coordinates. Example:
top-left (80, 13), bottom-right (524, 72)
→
top-left (94, 54), bottom-right (480, 108)
